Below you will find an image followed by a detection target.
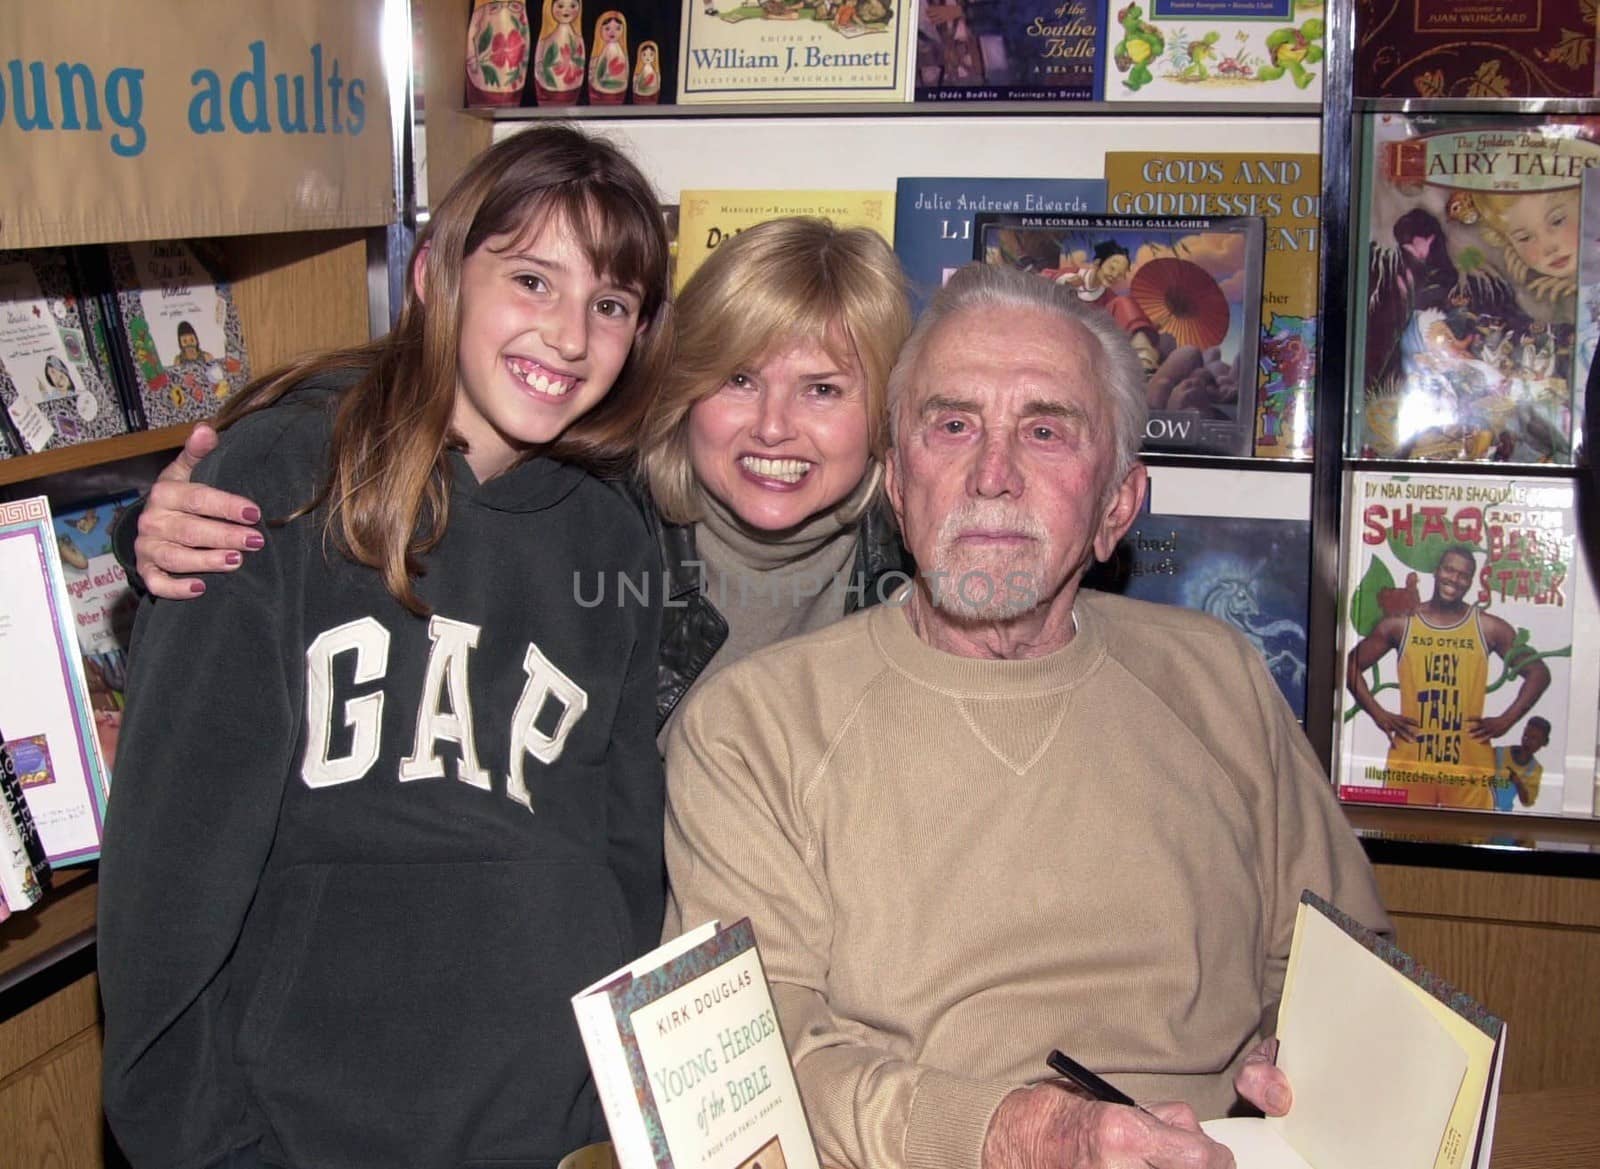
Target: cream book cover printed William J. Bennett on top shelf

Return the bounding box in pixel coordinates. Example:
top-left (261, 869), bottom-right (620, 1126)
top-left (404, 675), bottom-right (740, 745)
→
top-left (678, 0), bottom-right (917, 106)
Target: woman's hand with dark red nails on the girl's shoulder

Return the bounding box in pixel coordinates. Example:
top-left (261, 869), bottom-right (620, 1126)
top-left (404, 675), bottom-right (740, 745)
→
top-left (133, 422), bottom-right (266, 601)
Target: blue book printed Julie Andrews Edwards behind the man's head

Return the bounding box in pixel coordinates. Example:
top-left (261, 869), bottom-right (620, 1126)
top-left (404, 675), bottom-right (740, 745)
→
top-left (894, 178), bottom-right (1106, 312)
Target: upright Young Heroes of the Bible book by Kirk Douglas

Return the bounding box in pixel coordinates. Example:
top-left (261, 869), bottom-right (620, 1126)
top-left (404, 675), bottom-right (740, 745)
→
top-left (573, 918), bottom-right (818, 1169)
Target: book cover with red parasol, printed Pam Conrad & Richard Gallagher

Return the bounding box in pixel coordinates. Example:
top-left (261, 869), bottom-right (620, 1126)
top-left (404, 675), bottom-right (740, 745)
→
top-left (973, 213), bottom-right (1264, 456)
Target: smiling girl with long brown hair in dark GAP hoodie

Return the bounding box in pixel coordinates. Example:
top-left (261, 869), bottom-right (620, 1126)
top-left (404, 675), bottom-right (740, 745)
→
top-left (99, 128), bottom-right (670, 1169)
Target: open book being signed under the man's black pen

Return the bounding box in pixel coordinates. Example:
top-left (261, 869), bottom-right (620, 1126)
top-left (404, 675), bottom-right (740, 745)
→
top-left (1202, 892), bottom-right (1506, 1169)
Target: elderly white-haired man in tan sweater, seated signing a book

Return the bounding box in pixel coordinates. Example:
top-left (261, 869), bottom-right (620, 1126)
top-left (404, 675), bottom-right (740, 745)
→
top-left (667, 265), bottom-right (1387, 1169)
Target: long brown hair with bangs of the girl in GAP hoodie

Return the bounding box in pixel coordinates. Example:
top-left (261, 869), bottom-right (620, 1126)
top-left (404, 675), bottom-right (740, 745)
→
top-left (216, 125), bottom-right (672, 616)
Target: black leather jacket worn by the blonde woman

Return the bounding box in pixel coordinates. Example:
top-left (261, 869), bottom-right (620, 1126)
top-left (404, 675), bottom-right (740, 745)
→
top-left (656, 505), bottom-right (914, 731)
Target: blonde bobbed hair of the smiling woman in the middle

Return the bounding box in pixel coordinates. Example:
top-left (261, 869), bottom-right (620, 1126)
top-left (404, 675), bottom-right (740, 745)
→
top-left (640, 216), bottom-right (912, 523)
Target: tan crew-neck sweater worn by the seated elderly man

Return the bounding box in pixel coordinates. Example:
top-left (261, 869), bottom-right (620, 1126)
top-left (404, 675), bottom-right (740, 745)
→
top-left (667, 593), bottom-right (1389, 1169)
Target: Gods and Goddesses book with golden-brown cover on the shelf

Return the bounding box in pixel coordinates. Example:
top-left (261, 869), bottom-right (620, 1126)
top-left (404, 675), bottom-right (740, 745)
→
top-left (1106, 150), bottom-right (1322, 459)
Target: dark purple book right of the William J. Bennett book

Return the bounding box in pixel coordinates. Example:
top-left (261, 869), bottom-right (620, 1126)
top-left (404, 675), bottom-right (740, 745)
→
top-left (915, 0), bottom-right (1104, 101)
